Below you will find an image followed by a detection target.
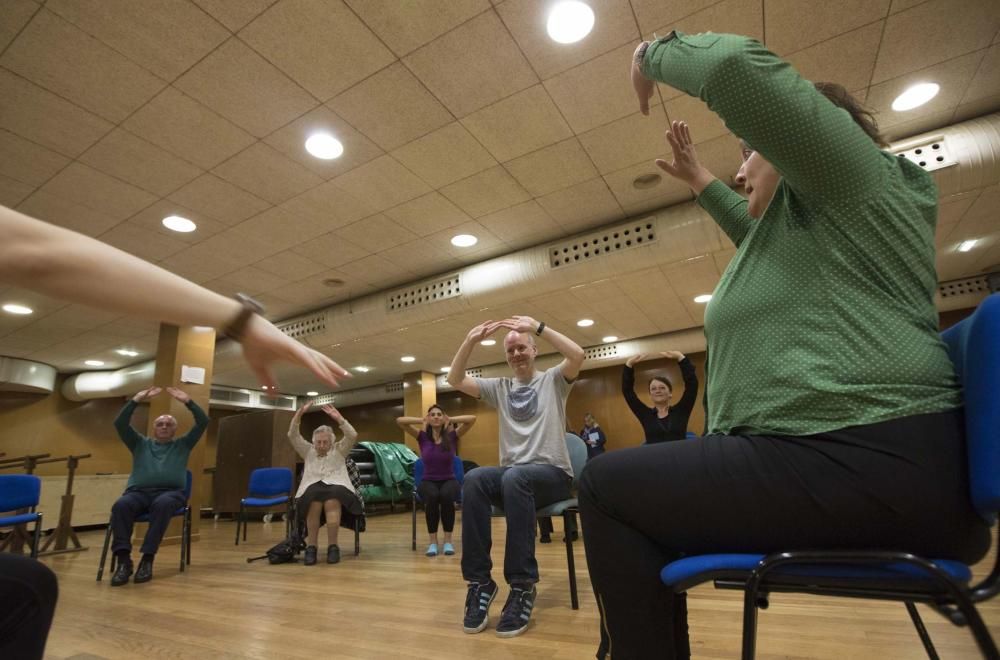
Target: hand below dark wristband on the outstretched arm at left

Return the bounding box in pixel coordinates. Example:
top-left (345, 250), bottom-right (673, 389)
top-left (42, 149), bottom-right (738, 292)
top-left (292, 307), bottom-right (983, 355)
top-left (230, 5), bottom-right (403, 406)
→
top-left (242, 316), bottom-right (351, 390)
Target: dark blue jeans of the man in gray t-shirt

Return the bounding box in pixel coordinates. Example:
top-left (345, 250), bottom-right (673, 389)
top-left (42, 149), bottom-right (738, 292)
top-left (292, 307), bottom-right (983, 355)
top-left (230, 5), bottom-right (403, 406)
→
top-left (462, 465), bottom-right (572, 584)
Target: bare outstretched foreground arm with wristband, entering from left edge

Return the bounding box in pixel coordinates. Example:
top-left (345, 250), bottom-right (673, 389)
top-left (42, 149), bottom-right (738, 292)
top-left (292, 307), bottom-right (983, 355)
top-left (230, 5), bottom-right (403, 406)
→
top-left (0, 206), bottom-right (350, 388)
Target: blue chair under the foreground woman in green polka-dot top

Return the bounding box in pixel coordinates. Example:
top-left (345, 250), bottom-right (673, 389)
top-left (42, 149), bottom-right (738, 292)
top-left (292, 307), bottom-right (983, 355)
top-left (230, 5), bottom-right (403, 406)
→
top-left (660, 294), bottom-right (1000, 660)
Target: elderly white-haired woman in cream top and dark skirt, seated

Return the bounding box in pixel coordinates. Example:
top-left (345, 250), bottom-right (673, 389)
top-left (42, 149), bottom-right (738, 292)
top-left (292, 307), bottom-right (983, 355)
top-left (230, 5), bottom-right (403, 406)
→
top-left (288, 403), bottom-right (362, 566)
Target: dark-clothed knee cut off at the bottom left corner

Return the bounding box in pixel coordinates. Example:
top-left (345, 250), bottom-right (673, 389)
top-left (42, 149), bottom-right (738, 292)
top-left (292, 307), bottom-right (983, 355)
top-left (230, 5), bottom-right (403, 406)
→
top-left (0, 553), bottom-right (59, 660)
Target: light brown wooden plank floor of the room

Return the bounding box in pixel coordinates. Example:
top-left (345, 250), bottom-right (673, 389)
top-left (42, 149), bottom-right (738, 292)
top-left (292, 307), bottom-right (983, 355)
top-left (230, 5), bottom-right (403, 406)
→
top-left (35, 513), bottom-right (1000, 660)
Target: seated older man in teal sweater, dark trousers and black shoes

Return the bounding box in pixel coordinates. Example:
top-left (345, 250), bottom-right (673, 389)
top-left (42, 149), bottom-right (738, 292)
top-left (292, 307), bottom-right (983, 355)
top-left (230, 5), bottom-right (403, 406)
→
top-left (111, 387), bottom-right (208, 587)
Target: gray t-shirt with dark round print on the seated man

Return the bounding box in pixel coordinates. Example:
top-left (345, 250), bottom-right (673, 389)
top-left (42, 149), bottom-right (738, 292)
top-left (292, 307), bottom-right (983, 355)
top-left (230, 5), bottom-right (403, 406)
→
top-left (476, 366), bottom-right (573, 476)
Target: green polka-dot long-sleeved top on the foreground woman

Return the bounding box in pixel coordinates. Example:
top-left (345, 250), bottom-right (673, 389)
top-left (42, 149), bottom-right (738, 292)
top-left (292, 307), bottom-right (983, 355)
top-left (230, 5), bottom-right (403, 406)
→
top-left (642, 33), bottom-right (961, 436)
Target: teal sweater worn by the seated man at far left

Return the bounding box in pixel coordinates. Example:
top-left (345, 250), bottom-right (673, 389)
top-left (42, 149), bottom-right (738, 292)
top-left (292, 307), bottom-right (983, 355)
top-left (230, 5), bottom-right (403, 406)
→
top-left (115, 399), bottom-right (208, 490)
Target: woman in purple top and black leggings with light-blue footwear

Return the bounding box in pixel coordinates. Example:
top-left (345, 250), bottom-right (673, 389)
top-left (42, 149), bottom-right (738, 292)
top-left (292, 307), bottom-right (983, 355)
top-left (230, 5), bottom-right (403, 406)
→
top-left (396, 404), bottom-right (476, 557)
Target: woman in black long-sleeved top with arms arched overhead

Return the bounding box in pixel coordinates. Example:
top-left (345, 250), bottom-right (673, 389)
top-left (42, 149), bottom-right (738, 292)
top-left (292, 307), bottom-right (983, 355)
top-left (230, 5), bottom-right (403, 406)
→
top-left (622, 351), bottom-right (698, 445)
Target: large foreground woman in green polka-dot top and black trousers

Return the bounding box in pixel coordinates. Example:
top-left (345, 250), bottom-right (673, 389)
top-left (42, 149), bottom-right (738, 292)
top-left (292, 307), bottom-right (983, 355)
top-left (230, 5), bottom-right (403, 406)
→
top-left (580, 32), bottom-right (989, 660)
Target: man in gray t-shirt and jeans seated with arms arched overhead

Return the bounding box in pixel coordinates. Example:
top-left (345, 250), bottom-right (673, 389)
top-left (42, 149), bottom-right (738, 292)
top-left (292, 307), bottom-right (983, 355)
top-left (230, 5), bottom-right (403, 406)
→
top-left (448, 316), bottom-right (584, 637)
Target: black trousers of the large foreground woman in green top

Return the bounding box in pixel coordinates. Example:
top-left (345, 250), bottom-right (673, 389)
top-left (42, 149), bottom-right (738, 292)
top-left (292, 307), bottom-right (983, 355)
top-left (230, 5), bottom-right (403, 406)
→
top-left (579, 411), bottom-right (990, 660)
